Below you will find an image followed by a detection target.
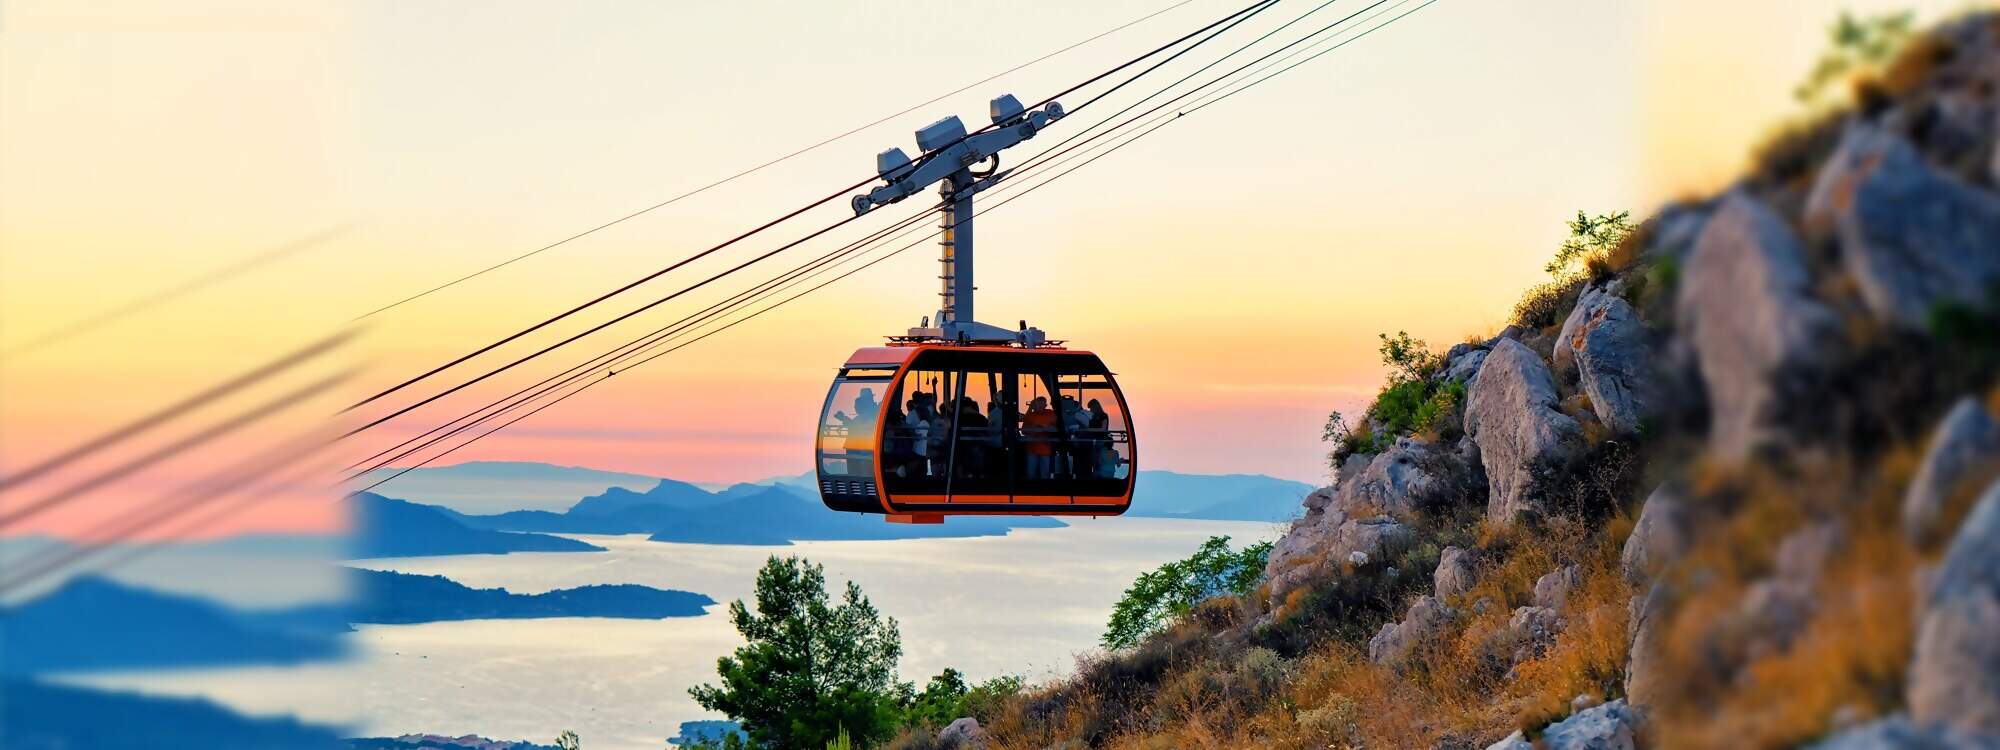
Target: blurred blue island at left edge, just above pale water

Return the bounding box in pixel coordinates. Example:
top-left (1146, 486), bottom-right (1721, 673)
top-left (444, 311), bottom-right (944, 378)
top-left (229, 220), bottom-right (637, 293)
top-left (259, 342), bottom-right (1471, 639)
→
top-left (0, 576), bottom-right (346, 676)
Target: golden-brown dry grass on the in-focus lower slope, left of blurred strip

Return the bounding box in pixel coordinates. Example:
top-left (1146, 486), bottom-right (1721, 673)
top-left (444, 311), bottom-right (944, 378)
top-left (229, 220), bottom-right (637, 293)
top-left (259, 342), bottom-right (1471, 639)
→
top-left (990, 518), bottom-right (1630, 750)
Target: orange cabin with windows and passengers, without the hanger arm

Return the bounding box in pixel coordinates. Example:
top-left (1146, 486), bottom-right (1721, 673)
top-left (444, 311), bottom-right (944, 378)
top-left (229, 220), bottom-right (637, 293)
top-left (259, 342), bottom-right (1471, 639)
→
top-left (816, 344), bottom-right (1136, 522)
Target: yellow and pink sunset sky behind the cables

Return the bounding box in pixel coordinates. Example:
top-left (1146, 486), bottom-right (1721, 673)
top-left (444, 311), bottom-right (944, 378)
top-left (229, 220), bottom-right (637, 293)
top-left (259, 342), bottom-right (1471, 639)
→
top-left (0, 0), bottom-right (1962, 532)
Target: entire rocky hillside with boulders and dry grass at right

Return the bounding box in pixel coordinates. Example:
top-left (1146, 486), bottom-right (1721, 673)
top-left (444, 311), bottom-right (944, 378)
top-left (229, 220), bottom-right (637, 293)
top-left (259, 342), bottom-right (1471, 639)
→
top-left (900, 14), bottom-right (2000, 750)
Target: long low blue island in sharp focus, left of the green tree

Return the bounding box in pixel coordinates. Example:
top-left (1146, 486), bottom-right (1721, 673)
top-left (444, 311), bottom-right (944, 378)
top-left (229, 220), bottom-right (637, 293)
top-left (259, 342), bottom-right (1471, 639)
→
top-left (350, 570), bottom-right (716, 624)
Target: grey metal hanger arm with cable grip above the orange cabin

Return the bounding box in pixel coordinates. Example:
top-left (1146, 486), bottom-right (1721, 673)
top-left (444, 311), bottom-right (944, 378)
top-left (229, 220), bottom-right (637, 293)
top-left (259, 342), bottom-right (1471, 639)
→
top-left (854, 94), bottom-right (1062, 346)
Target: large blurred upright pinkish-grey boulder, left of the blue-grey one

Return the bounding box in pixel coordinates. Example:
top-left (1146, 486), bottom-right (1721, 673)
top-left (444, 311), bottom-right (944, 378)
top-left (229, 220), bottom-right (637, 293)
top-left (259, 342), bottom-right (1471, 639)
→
top-left (1674, 192), bottom-right (1836, 460)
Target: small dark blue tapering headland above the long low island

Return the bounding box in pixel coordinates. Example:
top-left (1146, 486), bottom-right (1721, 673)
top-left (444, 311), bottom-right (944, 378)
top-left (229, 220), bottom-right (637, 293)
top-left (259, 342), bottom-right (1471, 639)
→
top-left (346, 492), bottom-right (604, 558)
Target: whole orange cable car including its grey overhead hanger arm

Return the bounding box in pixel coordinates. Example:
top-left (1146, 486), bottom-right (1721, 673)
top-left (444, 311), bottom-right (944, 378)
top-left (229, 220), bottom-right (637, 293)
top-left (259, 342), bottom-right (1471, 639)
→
top-left (814, 96), bottom-right (1136, 524)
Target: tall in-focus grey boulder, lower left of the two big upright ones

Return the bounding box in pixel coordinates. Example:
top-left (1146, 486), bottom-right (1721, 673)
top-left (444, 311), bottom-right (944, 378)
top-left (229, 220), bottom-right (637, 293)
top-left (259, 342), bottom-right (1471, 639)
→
top-left (1466, 338), bottom-right (1582, 522)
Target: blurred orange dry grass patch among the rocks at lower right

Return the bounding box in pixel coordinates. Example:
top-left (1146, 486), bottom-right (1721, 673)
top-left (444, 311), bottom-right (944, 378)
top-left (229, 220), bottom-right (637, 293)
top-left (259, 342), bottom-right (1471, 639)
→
top-left (1654, 448), bottom-right (1920, 748)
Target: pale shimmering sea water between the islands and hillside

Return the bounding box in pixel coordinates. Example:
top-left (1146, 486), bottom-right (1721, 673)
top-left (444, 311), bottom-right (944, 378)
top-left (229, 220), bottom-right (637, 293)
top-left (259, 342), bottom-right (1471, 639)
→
top-left (68, 518), bottom-right (1280, 750)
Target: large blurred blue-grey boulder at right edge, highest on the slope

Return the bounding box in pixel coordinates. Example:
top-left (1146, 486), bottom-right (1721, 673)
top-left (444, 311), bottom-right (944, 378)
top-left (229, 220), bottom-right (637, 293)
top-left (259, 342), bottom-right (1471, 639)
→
top-left (1806, 126), bottom-right (2000, 332)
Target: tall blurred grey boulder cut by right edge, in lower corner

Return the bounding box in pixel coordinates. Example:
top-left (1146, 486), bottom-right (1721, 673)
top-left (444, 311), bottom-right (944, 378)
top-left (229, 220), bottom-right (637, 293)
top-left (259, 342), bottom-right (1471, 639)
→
top-left (1906, 482), bottom-right (2000, 734)
